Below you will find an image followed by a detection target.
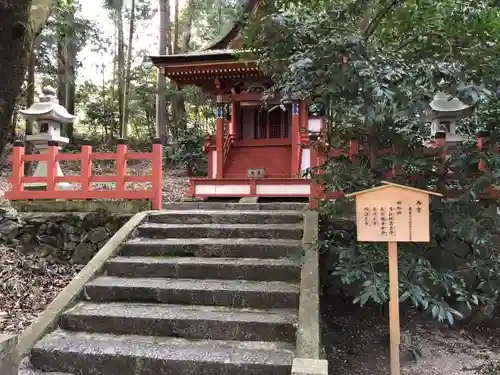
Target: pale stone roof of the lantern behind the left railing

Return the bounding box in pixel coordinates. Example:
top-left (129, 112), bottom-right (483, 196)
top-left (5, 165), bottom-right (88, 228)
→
top-left (19, 86), bottom-right (75, 124)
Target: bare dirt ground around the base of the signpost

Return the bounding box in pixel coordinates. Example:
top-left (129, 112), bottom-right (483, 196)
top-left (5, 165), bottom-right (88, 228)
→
top-left (322, 296), bottom-right (500, 375)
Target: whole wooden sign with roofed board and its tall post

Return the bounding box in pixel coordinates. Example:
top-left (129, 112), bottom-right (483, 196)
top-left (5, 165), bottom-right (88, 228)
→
top-left (346, 182), bottom-right (442, 375)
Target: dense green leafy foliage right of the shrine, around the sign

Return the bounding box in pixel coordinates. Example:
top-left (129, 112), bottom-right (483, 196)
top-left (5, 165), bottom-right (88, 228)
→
top-left (246, 0), bottom-right (500, 324)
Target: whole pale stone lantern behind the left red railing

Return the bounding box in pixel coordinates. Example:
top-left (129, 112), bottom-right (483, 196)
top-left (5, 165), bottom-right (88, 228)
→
top-left (20, 87), bottom-right (75, 190)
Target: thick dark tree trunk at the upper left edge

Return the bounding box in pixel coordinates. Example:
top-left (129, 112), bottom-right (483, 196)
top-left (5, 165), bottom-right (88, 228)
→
top-left (0, 0), bottom-right (31, 159)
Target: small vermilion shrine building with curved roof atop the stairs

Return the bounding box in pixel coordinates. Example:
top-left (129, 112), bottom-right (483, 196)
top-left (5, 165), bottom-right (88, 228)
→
top-left (152, 0), bottom-right (323, 198)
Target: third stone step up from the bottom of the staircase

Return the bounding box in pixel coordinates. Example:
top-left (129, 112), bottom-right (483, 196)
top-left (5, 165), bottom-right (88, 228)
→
top-left (84, 276), bottom-right (299, 309)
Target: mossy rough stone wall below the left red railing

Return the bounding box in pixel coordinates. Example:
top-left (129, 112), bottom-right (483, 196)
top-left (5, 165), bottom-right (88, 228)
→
top-left (0, 209), bottom-right (132, 264)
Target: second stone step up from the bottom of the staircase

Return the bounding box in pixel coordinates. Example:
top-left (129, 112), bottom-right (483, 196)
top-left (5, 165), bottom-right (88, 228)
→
top-left (60, 302), bottom-right (297, 342)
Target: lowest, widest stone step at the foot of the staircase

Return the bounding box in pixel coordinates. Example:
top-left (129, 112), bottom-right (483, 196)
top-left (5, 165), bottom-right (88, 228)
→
top-left (31, 330), bottom-right (293, 375)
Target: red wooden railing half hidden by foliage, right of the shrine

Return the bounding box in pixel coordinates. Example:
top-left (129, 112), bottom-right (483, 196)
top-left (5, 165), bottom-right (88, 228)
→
top-left (310, 134), bottom-right (500, 208)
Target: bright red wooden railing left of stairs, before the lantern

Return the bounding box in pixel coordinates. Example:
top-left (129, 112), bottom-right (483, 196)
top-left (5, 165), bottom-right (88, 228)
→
top-left (5, 139), bottom-right (163, 210)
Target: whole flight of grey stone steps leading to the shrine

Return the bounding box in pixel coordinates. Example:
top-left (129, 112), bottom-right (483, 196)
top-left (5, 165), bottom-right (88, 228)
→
top-left (30, 210), bottom-right (303, 375)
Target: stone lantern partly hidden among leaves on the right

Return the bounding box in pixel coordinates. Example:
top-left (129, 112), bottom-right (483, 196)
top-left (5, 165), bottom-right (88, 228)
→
top-left (429, 92), bottom-right (472, 143)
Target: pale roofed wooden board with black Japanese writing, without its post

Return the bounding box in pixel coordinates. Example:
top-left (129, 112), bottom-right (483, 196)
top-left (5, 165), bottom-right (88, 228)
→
top-left (349, 183), bottom-right (439, 242)
